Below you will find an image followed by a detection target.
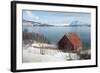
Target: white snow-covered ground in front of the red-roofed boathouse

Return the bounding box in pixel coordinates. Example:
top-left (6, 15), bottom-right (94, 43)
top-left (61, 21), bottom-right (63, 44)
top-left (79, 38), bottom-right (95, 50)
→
top-left (23, 44), bottom-right (79, 63)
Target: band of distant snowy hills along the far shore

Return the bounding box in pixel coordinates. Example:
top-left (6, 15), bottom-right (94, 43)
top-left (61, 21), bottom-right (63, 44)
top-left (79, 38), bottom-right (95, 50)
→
top-left (23, 20), bottom-right (91, 27)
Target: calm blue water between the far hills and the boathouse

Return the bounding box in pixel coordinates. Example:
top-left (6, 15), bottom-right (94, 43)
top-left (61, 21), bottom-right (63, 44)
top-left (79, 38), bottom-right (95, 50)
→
top-left (23, 26), bottom-right (91, 48)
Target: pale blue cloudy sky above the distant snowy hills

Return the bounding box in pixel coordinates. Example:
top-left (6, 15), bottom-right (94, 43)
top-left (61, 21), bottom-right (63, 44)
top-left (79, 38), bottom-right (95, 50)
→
top-left (23, 10), bottom-right (91, 25)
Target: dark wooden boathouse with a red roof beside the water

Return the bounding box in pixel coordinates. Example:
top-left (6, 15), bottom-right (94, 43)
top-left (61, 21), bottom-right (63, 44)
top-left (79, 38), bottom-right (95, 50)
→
top-left (58, 32), bottom-right (82, 52)
